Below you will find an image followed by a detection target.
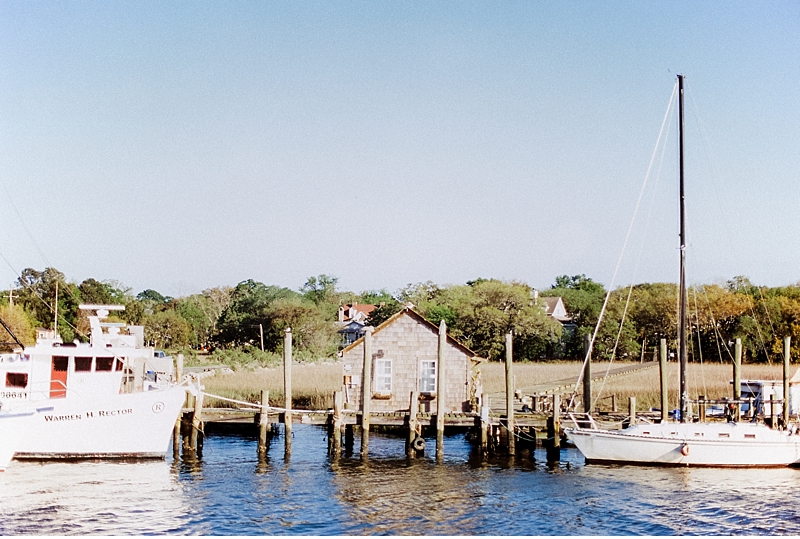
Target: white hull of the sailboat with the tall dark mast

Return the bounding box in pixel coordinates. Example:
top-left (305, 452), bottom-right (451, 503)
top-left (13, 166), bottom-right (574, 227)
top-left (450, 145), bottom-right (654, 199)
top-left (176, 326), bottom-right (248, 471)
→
top-left (566, 423), bottom-right (800, 467)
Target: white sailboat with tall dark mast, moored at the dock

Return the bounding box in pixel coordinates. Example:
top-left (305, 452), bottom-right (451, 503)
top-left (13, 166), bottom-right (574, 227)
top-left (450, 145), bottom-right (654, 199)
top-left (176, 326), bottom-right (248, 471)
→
top-left (565, 75), bottom-right (800, 467)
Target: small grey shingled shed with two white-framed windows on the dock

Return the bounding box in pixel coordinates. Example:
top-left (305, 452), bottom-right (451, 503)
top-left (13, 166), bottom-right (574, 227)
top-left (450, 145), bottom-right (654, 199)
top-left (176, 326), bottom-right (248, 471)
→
top-left (341, 307), bottom-right (482, 412)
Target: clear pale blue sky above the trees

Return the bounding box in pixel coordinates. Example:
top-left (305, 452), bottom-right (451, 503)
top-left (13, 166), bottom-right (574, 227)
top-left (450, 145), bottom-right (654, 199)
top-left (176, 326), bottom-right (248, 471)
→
top-left (0, 0), bottom-right (800, 297)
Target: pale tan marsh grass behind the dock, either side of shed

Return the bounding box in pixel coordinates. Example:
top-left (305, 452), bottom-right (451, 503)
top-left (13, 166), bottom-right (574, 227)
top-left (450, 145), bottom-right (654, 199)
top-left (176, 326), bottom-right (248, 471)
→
top-left (203, 361), bottom-right (794, 410)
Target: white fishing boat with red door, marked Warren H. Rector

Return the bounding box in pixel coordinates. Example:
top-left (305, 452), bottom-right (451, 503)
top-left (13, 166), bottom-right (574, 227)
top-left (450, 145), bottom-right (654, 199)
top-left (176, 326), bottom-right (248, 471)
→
top-left (0, 305), bottom-right (187, 459)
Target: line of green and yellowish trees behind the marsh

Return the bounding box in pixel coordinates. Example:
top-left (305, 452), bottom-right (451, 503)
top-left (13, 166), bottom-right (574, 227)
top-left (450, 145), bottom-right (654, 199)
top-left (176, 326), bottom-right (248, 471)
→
top-left (0, 268), bottom-right (800, 362)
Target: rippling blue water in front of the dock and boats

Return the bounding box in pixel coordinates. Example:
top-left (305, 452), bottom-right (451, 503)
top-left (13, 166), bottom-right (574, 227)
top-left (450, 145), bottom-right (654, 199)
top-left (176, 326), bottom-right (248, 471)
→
top-left (0, 425), bottom-right (800, 535)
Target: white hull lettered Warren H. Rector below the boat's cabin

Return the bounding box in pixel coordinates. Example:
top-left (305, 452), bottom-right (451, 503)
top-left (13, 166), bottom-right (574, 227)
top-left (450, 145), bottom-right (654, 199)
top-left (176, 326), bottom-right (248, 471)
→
top-left (11, 386), bottom-right (186, 459)
